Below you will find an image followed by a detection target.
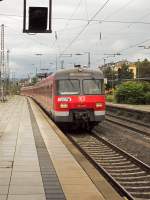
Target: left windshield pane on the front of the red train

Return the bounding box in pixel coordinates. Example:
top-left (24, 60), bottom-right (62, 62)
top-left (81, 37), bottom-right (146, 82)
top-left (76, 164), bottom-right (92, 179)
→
top-left (57, 79), bottom-right (80, 95)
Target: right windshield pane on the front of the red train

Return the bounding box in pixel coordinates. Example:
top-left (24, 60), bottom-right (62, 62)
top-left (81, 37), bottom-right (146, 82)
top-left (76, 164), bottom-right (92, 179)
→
top-left (83, 79), bottom-right (103, 95)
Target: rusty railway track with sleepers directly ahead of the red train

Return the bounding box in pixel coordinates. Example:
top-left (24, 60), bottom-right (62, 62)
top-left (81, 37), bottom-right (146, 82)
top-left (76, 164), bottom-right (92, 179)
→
top-left (67, 131), bottom-right (150, 200)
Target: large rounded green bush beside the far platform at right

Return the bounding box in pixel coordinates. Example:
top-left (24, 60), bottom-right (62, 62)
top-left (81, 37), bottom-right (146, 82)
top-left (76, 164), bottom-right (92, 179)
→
top-left (115, 81), bottom-right (146, 104)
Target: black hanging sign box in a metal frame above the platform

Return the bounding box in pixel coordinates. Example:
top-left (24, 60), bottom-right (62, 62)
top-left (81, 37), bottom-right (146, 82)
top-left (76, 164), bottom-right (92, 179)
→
top-left (23, 0), bottom-right (52, 33)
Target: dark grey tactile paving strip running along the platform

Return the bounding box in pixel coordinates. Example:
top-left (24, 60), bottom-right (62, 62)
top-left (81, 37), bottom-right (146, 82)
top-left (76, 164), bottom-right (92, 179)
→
top-left (28, 102), bottom-right (66, 200)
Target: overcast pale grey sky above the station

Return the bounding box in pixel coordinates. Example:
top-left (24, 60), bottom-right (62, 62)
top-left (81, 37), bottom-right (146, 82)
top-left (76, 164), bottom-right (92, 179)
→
top-left (0, 0), bottom-right (150, 77)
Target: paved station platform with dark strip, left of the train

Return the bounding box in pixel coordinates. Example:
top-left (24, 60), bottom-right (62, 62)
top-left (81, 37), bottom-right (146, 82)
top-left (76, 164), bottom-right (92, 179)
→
top-left (0, 96), bottom-right (122, 200)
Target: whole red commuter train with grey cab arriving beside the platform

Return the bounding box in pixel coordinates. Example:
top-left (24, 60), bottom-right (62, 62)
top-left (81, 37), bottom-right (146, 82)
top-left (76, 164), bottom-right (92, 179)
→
top-left (21, 68), bottom-right (105, 128)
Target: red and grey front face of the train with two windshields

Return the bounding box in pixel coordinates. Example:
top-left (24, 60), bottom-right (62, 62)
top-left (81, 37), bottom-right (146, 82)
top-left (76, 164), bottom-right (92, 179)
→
top-left (54, 68), bottom-right (105, 128)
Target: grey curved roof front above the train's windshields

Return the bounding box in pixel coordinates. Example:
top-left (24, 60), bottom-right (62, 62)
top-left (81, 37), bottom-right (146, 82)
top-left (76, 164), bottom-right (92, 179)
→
top-left (53, 68), bottom-right (104, 79)
